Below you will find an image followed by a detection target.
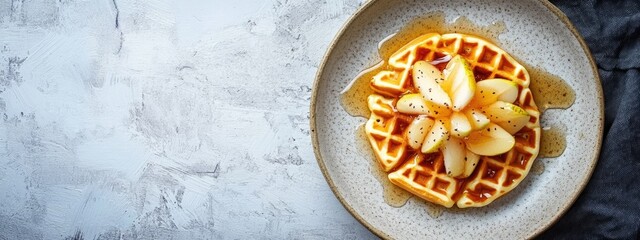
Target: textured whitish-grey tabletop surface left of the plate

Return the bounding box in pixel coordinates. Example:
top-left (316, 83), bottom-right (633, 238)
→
top-left (0, 0), bottom-right (373, 239)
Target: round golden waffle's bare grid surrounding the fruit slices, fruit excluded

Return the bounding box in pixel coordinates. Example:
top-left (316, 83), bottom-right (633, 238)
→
top-left (365, 33), bottom-right (540, 208)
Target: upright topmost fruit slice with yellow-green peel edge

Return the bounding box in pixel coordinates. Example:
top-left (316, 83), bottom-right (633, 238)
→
top-left (442, 55), bottom-right (476, 111)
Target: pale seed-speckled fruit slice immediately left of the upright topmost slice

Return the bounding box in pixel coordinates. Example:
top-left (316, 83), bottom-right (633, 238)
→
top-left (412, 61), bottom-right (451, 108)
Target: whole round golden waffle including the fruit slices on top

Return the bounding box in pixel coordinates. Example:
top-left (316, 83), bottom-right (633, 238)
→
top-left (365, 33), bottom-right (540, 208)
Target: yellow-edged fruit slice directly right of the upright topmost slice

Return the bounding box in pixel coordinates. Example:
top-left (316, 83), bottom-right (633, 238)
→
top-left (471, 78), bottom-right (518, 107)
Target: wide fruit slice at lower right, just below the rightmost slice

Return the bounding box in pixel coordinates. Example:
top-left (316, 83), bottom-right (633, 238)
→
top-left (465, 123), bottom-right (516, 156)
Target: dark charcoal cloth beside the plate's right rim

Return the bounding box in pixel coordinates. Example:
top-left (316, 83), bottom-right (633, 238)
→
top-left (539, 0), bottom-right (640, 239)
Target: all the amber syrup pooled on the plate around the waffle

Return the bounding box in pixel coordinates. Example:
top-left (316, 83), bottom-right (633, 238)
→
top-left (341, 12), bottom-right (575, 208)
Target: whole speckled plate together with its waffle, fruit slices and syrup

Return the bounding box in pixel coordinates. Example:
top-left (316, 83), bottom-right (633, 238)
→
top-left (310, 0), bottom-right (604, 239)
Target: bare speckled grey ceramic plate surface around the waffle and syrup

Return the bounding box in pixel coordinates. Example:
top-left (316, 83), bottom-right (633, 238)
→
top-left (311, 0), bottom-right (604, 239)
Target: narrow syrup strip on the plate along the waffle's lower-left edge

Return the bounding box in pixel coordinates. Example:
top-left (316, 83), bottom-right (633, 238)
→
top-left (356, 123), bottom-right (413, 207)
